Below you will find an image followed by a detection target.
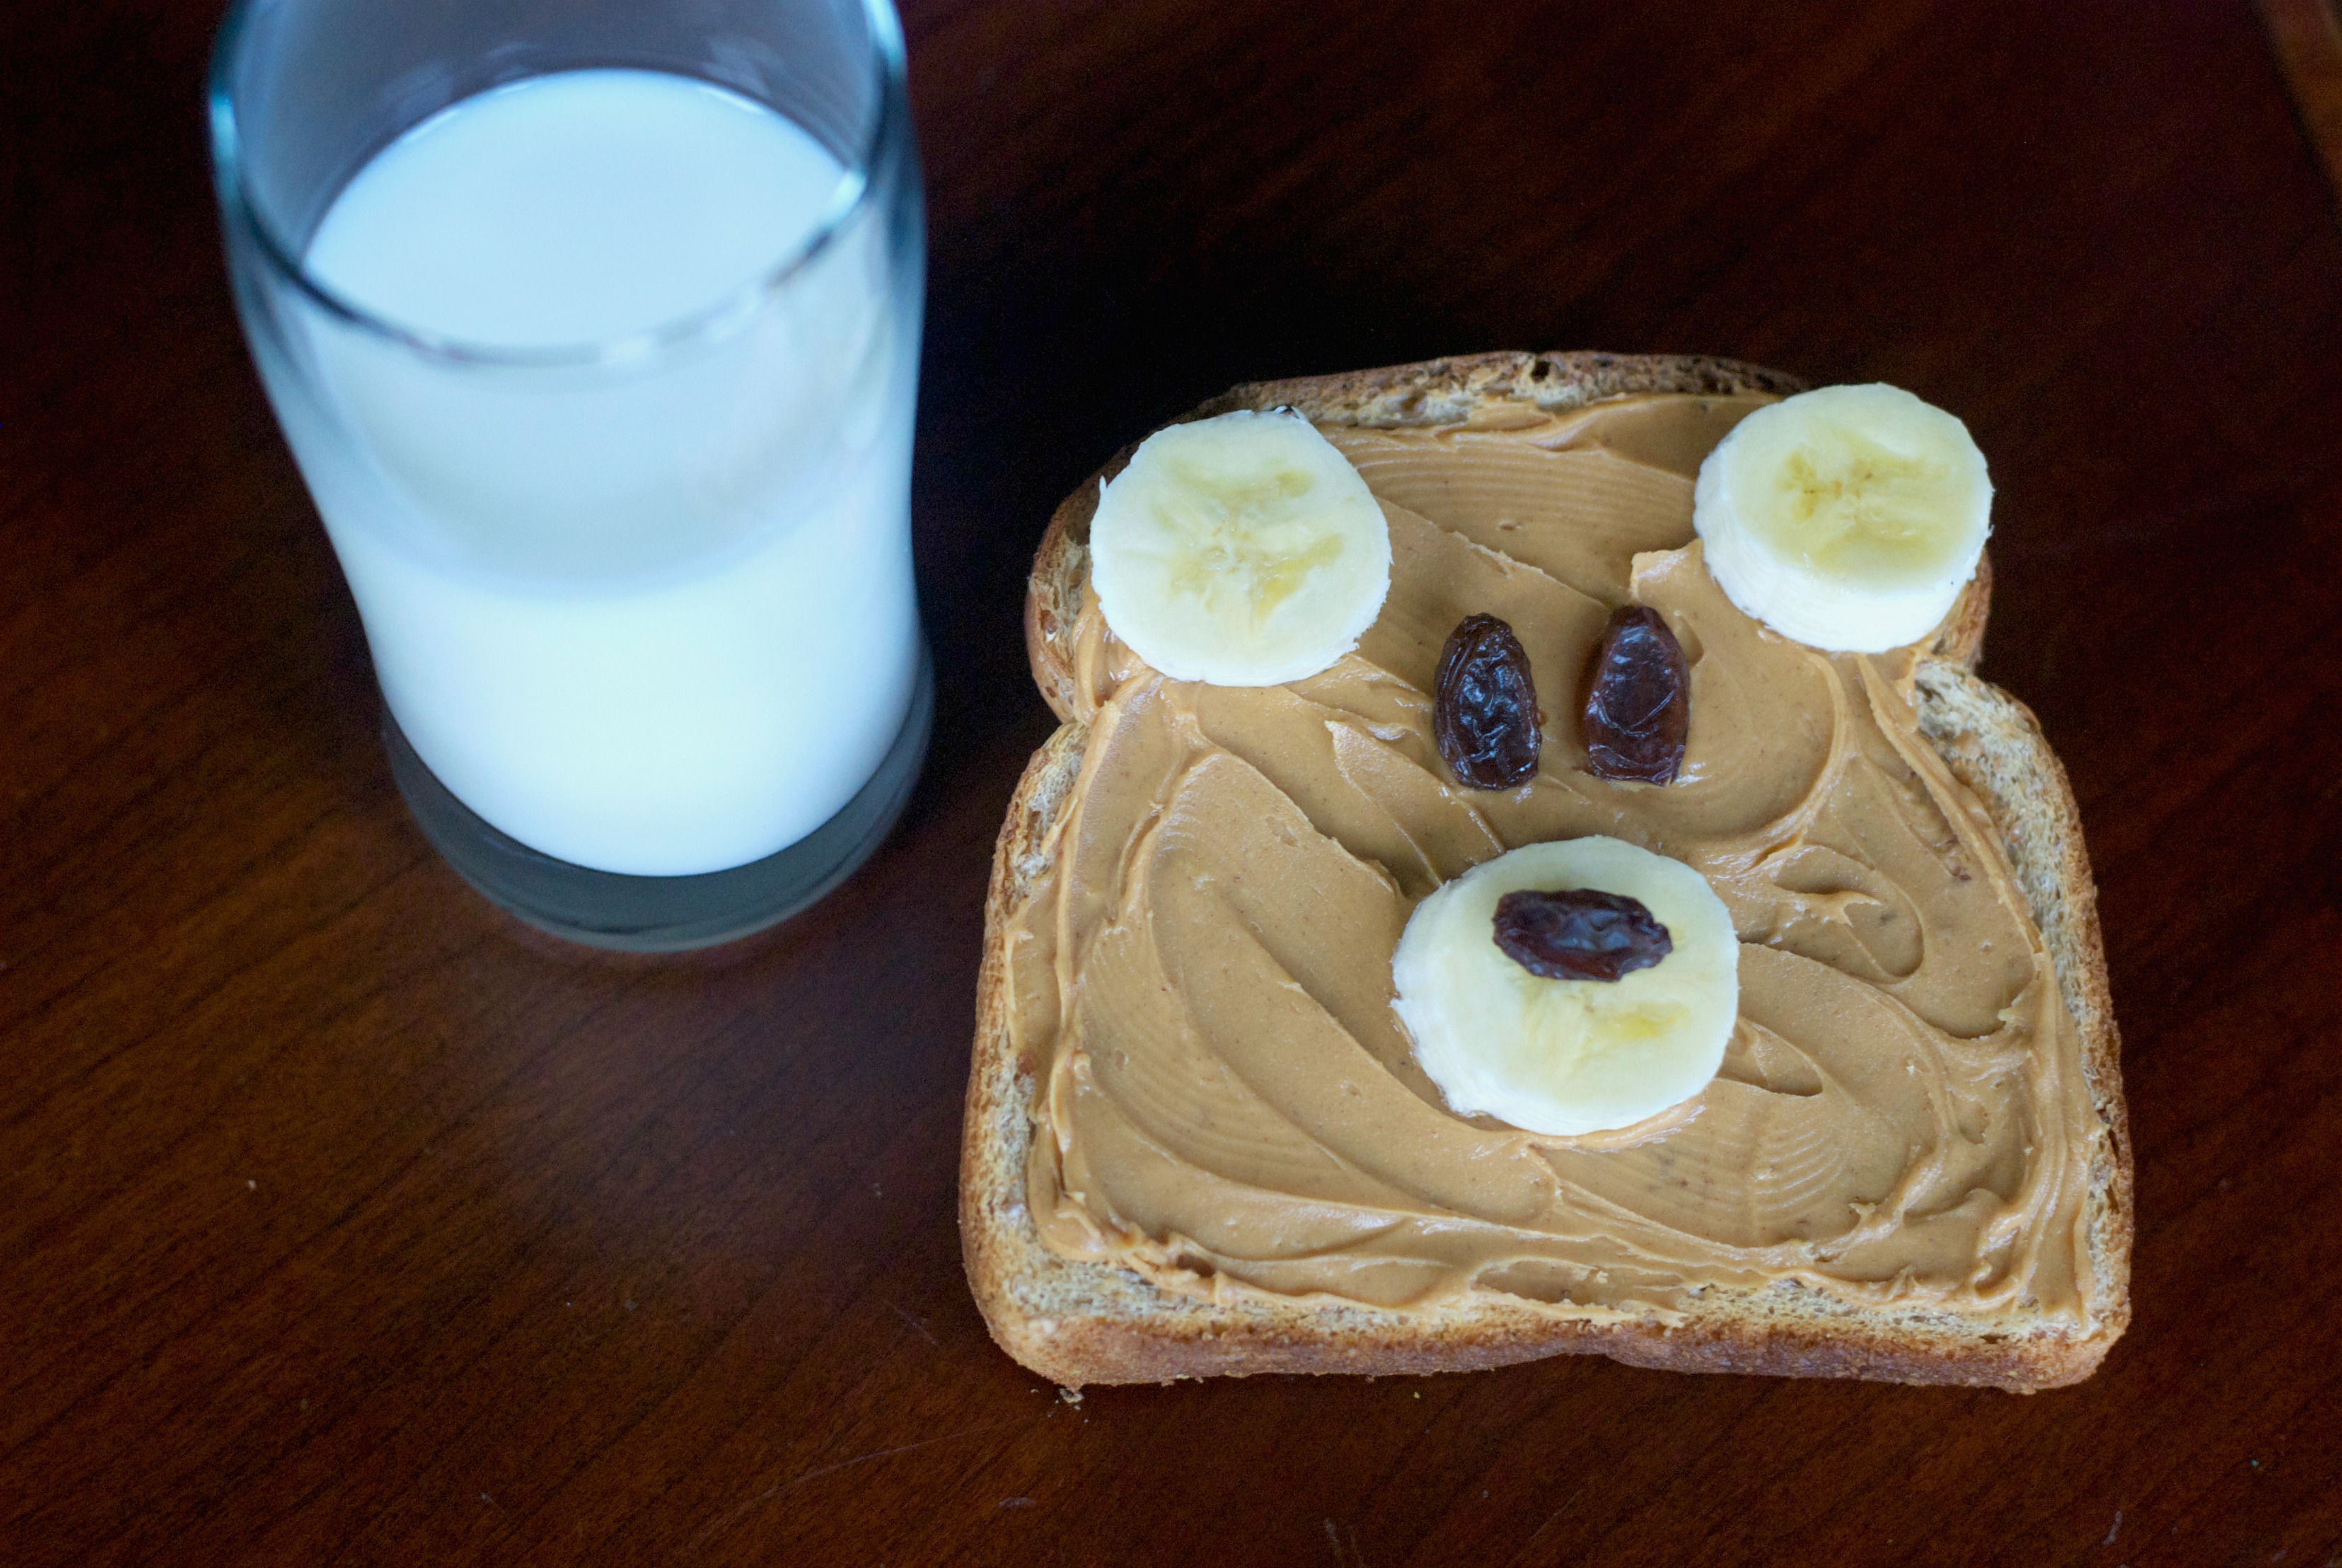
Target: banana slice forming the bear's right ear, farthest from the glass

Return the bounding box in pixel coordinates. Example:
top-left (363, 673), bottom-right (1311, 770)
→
top-left (1691, 384), bottom-right (1993, 653)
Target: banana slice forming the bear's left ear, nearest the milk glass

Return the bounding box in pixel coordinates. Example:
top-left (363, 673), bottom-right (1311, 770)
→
top-left (1089, 410), bottom-right (1391, 686)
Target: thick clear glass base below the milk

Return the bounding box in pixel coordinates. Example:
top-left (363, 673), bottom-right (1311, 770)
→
top-left (382, 649), bottom-right (934, 953)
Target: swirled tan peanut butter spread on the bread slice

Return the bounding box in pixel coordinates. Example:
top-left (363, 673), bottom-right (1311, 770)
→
top-left (1009, 395), bottom-right (2101, 1320)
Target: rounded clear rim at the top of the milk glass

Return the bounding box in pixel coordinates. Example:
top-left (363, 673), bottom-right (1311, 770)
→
top-left (206, 0), bottom-right (909, 370)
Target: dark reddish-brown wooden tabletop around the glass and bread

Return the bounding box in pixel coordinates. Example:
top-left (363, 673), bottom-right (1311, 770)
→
top-left (0, 0), bottom-right (2342, 1568)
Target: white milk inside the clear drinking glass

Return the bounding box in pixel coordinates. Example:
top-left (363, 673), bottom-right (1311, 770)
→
top-left (286, 70), bottom-right (918, 876)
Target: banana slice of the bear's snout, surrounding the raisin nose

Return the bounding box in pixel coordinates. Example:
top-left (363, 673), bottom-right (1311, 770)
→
top-left (1391, 838), bottom-right (1740, 1137)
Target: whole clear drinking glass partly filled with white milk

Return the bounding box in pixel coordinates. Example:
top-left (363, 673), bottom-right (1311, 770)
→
top-left (211, 0), bottom-right (932, 950)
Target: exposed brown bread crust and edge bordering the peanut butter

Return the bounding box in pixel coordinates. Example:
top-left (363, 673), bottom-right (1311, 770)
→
top-left (961, 354), bottom-right (2131, 1393)
